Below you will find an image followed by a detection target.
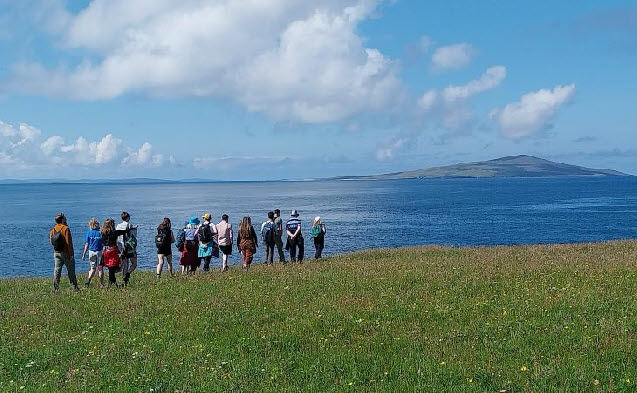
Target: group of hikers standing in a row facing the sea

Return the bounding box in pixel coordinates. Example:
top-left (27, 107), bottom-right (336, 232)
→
top-left (49, 209), bottom-right (327, 291)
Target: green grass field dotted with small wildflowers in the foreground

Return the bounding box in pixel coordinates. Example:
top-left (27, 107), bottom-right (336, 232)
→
top-left (0, 242), bottom-right (637, 392)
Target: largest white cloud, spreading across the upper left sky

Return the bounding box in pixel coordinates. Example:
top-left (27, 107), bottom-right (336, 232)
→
top-left (4, 0), bottom-right (403, 123)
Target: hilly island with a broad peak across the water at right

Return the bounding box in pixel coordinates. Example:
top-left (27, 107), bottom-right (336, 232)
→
top-left (334, 155), bottom-right (630, 180)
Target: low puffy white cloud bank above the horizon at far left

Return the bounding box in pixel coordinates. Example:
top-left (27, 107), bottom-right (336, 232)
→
top-left (0, 122), bottom-right (164, 175)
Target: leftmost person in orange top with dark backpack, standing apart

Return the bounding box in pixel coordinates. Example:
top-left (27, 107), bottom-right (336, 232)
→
top-left (49, 213), bottom-right (80, 292)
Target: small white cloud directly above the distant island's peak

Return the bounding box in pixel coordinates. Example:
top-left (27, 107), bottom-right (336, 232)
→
top-left (490, 84), bottom-right (575, 139)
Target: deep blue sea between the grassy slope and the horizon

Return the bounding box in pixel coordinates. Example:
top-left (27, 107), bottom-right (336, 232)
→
top-left (0, 177), bottom-right (637, 277)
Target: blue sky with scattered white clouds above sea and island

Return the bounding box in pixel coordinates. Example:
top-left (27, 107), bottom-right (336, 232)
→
top-left (0, 0), bottom-right (637, 180)
